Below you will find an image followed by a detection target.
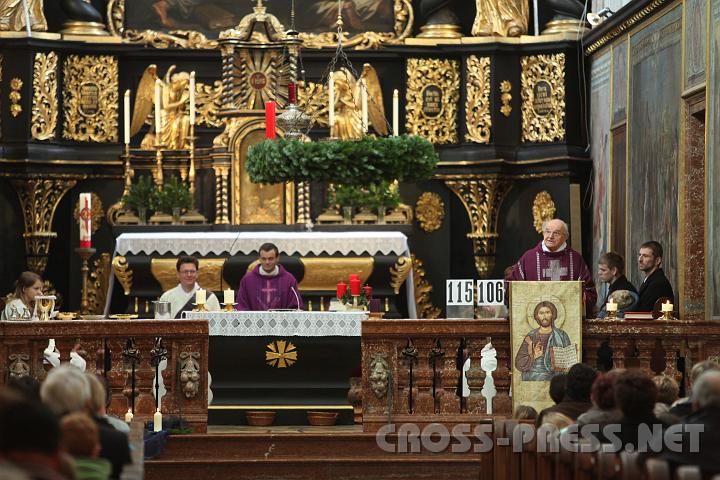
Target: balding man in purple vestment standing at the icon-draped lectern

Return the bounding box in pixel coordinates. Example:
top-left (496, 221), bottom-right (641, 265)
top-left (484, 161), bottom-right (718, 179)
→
top-left (508, 218), bottom-right (597, 316)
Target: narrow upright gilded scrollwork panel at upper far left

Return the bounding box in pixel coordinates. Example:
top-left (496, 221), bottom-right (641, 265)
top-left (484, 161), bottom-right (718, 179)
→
top-left (30, 52), bottom-right (58, 140)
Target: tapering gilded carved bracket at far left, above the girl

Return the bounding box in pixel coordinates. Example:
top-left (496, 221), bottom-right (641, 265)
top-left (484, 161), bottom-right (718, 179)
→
top-left (11, 178), bottom-right (77, 275)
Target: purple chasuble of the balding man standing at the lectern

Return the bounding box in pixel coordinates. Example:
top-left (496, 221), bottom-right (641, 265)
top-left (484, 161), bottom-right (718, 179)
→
top-left (509, 241), bottom-right (597, 317)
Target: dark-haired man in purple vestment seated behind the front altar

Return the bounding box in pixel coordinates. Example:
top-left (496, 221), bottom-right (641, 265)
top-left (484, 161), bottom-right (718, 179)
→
top-left (235, 243), bottom-right (303, 311)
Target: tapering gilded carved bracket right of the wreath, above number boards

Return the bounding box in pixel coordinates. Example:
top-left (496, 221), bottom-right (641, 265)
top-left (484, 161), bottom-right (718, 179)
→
top-left (445, 177), bottom-right (512, 278)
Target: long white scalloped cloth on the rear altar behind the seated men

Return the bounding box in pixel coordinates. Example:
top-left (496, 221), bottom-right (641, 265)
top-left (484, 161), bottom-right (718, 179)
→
top-left (115, 232), bottom-right (409, 256)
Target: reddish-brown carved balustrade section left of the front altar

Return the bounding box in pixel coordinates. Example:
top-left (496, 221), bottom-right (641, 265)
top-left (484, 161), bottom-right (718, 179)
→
top-left (0, 320), bottom-right (208, 433)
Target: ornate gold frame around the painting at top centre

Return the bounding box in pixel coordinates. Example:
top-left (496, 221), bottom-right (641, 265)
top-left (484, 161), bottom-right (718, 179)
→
top-left (106, 0), bottom-right (415, 50)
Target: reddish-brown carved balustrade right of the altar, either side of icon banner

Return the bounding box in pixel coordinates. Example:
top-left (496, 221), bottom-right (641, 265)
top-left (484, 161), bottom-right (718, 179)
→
top-left (362, 319), bottom-right (720, 431)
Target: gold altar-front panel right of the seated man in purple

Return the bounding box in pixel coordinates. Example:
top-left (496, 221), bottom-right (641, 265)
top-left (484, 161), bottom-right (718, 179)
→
top-left (298, 257), bottom-right (375, 292)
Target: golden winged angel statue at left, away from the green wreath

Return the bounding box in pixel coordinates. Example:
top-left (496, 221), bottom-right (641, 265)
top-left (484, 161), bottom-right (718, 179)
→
top-left (130, 65), bottom-right (190, 150)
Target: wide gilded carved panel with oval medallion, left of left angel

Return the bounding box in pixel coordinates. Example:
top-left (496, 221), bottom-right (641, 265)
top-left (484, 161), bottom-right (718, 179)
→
top-left (63, 55), bottom-right (118, 142)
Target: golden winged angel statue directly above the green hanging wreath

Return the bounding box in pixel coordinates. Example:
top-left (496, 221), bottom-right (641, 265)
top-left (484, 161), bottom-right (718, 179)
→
top-left (331, 63), bottom-right (388, 140)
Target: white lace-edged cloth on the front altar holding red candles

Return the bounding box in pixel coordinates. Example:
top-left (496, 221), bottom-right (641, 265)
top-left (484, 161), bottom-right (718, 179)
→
top-left (183, 311), bottom-right (367, 337)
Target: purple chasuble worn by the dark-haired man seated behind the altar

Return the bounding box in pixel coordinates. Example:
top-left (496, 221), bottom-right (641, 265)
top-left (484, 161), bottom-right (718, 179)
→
top-left (235, 265), bottom-right (303, 311)
